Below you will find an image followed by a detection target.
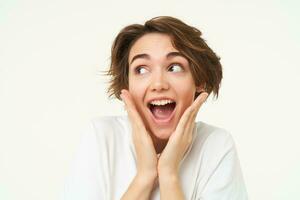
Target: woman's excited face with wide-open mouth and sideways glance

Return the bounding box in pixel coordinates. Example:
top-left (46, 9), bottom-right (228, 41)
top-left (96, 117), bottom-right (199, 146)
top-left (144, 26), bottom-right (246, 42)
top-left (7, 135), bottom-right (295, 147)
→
top-left (128, 33), bottom-right (200, 139)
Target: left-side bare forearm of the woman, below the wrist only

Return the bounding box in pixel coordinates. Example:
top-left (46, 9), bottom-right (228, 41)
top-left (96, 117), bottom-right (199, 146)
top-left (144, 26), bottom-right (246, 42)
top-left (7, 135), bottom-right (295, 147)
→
top-left (121, 175), bottom-right (155, 200)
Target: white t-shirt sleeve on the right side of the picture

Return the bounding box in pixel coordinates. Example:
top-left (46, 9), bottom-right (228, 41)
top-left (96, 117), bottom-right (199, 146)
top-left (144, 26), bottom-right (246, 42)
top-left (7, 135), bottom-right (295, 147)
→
top-left (196, 132), bottom-right (248, 200)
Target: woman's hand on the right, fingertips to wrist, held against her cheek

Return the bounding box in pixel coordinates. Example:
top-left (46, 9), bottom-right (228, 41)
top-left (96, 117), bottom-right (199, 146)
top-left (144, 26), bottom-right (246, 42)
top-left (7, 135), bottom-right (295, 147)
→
top-left (158, 92), bottom-right (208, 176)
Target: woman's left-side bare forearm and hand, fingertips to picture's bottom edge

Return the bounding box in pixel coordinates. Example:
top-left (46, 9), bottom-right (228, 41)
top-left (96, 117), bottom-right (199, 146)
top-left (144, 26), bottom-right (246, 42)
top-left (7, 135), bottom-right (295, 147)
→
top-left (121, 90), bottom-right (157, 200)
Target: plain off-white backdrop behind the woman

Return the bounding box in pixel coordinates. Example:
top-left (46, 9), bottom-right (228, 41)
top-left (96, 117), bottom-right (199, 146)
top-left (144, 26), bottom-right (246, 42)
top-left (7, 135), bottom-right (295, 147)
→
top-left (0, 0), bottom-right (300, 200)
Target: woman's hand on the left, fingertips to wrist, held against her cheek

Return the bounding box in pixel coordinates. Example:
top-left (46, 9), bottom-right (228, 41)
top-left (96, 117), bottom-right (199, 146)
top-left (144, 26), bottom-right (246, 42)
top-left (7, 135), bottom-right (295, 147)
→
top-left (120, 89), bottom-right (158, 181)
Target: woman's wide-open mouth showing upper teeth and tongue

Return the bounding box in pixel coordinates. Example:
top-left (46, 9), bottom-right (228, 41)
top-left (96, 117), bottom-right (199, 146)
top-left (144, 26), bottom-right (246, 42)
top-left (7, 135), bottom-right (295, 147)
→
top-left (148, 99), bottom-right (176, 124)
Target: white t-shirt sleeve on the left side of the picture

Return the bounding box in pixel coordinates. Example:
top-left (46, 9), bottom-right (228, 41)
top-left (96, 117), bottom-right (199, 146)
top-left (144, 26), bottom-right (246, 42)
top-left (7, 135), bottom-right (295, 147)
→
top-left (61, 121), bottom-right (107, 200)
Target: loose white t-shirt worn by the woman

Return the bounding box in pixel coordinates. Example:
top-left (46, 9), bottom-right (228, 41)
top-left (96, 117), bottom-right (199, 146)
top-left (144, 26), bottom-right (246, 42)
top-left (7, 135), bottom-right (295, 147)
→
top-left (63, 116), bottom-right (248, 200)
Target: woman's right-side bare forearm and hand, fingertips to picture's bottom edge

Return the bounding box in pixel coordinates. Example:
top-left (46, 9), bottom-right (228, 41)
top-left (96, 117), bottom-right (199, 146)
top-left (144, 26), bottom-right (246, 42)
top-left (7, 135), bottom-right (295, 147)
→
top-left (158, 93), bottom-right (208, 200)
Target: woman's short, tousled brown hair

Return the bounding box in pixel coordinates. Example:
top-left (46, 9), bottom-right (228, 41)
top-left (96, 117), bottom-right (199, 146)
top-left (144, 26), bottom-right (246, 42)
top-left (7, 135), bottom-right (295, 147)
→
top-left (106, 16), bottom-right (222, 99)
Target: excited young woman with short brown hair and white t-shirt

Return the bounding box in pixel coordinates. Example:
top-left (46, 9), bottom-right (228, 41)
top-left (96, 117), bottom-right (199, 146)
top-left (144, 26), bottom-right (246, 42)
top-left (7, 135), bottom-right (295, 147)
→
top-left (64, 16), bottom-right (247, 200)
